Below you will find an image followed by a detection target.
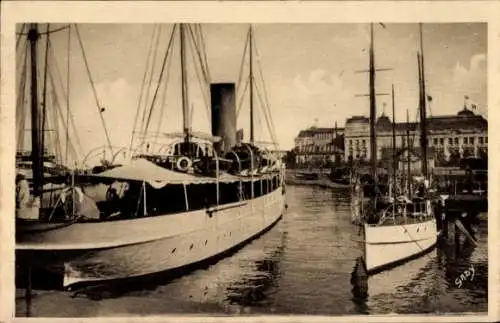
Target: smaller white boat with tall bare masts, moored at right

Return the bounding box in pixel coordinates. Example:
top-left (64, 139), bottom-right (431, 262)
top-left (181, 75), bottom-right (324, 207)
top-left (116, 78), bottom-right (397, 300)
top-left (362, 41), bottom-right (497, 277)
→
top-left (353, 25), bottom-right (438, 274)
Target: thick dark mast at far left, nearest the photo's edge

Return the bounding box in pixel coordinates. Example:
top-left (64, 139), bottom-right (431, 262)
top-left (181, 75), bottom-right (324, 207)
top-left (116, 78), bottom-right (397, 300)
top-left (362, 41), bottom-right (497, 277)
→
top-left (28, 24), bottom-right (42, 197)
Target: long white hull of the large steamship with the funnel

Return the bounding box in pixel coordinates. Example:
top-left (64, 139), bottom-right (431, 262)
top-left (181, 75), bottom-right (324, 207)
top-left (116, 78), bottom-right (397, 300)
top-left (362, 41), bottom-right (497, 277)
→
top-left (17, 188), bottom-right (284, 288)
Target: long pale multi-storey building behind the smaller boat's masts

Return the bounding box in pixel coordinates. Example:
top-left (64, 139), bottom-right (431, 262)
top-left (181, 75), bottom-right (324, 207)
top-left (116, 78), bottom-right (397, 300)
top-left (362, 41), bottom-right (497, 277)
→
top-left (344, 107), bottom-right (488, 164)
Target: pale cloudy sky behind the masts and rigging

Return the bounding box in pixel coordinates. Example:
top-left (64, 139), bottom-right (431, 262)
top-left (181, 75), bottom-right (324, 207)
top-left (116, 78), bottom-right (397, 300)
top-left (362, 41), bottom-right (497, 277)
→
top-left (17, 23), bottom-right (487, 162)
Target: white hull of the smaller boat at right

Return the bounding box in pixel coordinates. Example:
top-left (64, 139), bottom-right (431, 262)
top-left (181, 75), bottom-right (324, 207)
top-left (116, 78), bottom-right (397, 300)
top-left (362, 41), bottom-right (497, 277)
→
top-left (364, 218), bottom-right (438, 273)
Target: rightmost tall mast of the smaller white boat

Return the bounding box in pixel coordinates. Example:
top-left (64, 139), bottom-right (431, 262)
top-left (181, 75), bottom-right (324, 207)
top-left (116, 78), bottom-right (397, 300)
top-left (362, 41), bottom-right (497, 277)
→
top-left (419, 23), bottom-right (427, 178)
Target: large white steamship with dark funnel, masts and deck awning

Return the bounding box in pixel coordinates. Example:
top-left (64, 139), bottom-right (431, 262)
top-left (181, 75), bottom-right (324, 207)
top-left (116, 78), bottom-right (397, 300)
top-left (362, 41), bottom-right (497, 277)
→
top-left (16, 24), bottom-right (285, 289)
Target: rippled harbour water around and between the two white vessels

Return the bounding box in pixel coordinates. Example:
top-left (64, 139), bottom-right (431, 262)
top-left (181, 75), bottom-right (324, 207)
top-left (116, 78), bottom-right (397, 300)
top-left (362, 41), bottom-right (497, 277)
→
top-left (16, 186), bottom-right (488, 317)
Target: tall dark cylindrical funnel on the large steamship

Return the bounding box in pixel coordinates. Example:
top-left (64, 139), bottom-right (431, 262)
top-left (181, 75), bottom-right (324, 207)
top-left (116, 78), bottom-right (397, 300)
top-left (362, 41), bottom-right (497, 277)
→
top-left (210, 83), bottom-right (236, 152)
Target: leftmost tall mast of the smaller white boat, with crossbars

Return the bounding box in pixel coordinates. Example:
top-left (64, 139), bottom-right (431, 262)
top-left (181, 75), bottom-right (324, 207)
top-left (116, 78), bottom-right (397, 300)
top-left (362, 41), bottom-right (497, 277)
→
top-left (370, 23), bottom-right (378, 186)
